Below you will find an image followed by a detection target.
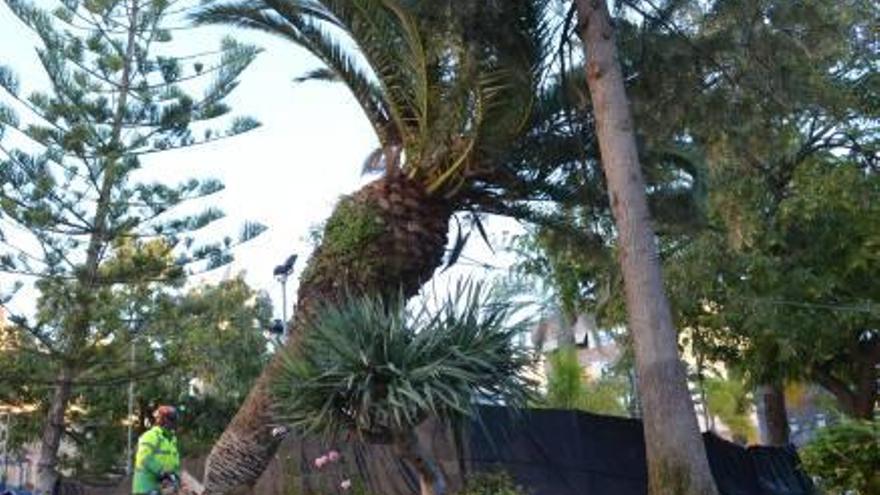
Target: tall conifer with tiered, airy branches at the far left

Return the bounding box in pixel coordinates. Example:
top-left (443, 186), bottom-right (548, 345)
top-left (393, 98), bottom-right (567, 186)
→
top-left (0, 0), bottom-right (264, 492)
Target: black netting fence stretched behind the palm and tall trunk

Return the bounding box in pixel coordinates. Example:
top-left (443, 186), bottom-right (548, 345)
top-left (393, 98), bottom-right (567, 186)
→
top-left (254, 407), bottom-right (815, 495)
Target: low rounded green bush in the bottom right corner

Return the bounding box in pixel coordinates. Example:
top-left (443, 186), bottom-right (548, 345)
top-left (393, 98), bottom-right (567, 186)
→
top-left (801, 421), bottom-right (880, 495)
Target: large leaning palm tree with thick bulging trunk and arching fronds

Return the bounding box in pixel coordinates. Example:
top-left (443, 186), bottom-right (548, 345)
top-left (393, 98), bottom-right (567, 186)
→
top-left (196, 0), bottom-right (549, 493)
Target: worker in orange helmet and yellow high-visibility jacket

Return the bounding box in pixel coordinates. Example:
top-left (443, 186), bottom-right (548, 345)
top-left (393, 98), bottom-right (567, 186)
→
top-left (131, 406), bottom-right (180, 495)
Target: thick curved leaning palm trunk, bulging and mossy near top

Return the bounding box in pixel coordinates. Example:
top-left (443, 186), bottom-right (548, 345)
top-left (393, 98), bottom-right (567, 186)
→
top-left (204, 174), bottom-right (452, 494)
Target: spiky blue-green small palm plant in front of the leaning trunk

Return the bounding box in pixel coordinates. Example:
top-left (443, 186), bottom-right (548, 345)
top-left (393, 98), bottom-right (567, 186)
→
top-left (273, 284), bottom-right (534, 495)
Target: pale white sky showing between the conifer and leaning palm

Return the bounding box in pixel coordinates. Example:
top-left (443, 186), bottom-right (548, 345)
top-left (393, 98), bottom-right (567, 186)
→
top-left (0, 2), bottom-right (519, 317)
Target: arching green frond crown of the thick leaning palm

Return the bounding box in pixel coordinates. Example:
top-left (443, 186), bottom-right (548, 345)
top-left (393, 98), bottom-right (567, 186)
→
top-left (196, 0), bottom-right (548, 197)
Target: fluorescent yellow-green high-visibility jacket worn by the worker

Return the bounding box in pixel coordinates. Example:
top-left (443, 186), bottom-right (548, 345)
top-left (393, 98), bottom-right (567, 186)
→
top-left (131, 426), bottom-right (180, 495)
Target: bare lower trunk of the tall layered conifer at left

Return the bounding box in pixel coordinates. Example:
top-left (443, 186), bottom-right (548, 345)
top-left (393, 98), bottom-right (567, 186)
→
top-left (36, 368), bottom-right (72, 494)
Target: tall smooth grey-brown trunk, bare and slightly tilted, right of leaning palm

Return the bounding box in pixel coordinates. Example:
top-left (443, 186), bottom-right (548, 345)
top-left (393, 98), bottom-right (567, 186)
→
top-left (576, 0), bottom-right (718, 495)
